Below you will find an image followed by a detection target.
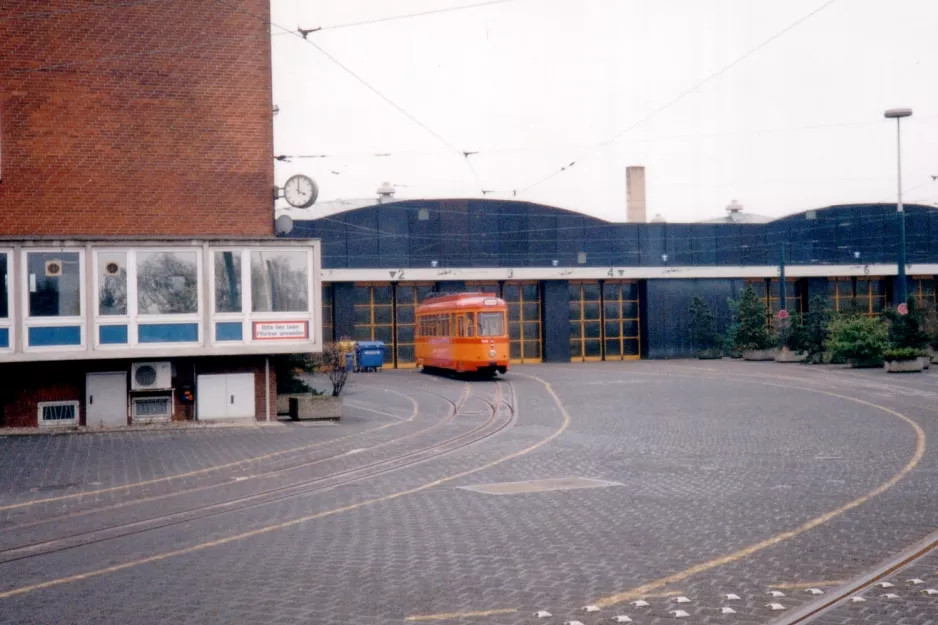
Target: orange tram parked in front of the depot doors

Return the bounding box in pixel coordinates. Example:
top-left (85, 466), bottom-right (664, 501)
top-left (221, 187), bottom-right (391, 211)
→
top-left (415, 293), bottom-right (508, 376)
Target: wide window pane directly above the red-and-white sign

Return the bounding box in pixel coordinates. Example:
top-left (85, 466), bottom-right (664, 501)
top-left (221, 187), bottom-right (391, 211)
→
top-left (251, 252), bottom-right (309, 312)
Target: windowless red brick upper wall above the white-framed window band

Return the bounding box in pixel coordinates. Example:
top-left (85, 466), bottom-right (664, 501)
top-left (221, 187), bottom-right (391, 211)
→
top-left (0, 0), bottom-right (274, 236)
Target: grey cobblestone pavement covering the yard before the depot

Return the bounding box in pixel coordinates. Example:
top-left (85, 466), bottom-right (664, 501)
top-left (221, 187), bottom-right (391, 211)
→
top-left (0, 361), bottom-right (938, 625)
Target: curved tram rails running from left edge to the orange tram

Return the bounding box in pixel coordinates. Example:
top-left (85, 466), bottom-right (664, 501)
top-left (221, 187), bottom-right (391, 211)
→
top-left (0, 382), bottom-right (516, 566)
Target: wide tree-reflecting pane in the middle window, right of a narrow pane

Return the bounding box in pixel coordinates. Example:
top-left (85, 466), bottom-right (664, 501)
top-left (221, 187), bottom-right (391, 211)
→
top-left (137, 252), bottom-right (199, 315)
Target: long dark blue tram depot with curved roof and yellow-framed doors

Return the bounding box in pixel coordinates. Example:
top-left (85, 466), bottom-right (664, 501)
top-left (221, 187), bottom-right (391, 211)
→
top-left (289, 198), bottom-right (938, 368)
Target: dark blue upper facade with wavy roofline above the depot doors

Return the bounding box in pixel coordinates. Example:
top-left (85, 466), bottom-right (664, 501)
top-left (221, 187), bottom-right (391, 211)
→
top-left (290, 200), bottom-right (938, 269)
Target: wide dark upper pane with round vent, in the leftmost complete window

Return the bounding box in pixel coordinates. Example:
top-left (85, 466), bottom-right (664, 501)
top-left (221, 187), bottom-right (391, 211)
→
top-left (26, 252), bottom-right (81, 317)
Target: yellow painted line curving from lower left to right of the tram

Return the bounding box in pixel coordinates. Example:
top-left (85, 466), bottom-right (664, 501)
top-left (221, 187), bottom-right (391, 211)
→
top-left (0, 374), bottom-right (570, 599)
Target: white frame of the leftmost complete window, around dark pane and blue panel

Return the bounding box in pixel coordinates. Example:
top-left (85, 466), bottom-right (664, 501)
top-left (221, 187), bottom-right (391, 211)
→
top-left (21, 246), bottom-right (88, 353)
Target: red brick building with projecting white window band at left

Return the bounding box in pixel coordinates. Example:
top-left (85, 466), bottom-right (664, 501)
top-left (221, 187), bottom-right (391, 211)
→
top-left (0, 0), bottom-right (321, 426)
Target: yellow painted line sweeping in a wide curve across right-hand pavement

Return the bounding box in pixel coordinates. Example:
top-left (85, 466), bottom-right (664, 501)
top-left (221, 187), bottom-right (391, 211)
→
top-left (595, 382), bottom-right (926, 607)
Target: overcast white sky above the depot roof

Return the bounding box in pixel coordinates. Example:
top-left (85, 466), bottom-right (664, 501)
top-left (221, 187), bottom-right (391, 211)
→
top-left (272, 0), bottom-right (938, 221)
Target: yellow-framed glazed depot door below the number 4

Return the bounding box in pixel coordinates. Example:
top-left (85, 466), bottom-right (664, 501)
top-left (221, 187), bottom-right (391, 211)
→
top-left (569, 280), bottom-right (641, 362)
